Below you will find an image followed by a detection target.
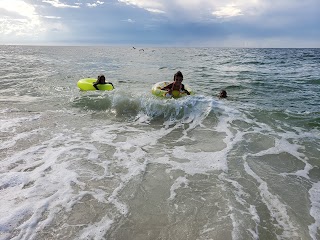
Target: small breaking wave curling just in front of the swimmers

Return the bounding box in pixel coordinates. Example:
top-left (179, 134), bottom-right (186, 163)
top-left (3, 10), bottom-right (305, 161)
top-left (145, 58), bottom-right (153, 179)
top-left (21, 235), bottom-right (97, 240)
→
top-left (71, 92), bottom-right (222, 123)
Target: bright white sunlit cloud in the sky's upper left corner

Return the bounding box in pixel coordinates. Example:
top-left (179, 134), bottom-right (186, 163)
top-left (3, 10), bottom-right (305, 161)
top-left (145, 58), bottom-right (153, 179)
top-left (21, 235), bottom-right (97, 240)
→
top-left (0, 0), bottom-right (78, 44)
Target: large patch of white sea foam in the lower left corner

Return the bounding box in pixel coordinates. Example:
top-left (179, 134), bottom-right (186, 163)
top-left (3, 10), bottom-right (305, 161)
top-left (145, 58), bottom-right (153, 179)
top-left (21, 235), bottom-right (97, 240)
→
top-left (0, 132), bottom-right (107, 239)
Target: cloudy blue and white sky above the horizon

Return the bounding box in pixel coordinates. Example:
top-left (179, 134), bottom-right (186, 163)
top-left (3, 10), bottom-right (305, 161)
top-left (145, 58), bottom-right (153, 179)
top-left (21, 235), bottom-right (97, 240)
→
top-left (0, 0), bottom-right (320, 48)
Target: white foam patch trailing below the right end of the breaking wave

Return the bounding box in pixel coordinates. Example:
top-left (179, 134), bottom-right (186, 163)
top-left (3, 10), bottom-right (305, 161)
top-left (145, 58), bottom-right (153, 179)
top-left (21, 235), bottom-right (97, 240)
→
top-left (149, 98), bottom-right (243, 175)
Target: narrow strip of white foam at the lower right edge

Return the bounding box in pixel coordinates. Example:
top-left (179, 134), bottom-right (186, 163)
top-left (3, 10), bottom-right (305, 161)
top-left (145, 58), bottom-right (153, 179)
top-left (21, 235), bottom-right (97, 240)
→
top-left (308, 182), bottom-right (320, 240)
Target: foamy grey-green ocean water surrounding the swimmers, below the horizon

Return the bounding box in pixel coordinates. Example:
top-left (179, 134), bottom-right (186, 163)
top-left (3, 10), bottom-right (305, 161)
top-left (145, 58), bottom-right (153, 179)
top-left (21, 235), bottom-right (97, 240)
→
top-left (0, 46), bottom-right (320, 240)
